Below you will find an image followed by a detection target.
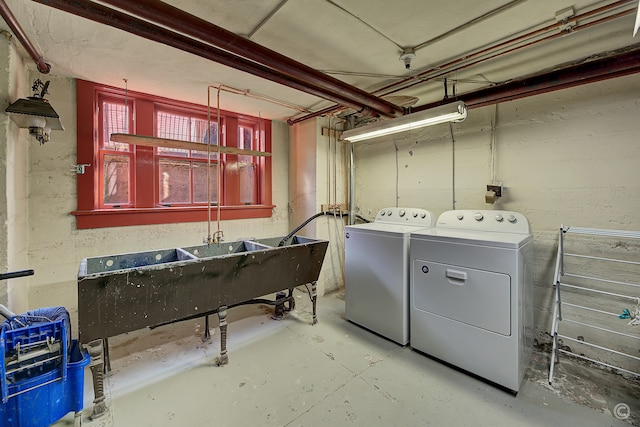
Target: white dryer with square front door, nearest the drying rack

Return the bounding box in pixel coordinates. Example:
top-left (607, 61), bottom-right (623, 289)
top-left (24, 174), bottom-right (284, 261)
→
top-left (410, 210), bottom-right (533, 392)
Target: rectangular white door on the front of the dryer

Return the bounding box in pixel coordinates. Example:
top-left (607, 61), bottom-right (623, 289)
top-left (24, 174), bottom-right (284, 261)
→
top-left (411, 259), bottom-right (511, 336)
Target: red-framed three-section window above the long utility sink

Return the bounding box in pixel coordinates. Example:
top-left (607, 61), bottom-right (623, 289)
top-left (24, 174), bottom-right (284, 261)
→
top-left (73, 80), bottom-right (273, 228)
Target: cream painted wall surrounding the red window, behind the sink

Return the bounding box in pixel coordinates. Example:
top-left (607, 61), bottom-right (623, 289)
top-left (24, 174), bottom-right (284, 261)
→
top-left (15, 76), bottom-right (289, 335)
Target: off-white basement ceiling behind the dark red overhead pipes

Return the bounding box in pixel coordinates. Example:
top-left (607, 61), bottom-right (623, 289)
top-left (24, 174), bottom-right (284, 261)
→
top-left (0, 0), bottom-right (640, 120)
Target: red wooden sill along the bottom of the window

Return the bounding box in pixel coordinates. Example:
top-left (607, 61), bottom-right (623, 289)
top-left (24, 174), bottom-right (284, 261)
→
top-left (71, 205), bottom-right (274, 230)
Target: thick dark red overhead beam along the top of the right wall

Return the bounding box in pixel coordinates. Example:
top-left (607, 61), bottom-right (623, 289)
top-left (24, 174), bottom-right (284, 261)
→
top-left (413, 47), bottom-right (640, 111)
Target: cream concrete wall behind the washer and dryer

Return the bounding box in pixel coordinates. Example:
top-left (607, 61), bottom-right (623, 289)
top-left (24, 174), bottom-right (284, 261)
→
top-left (355, 75), bottom-right (640, 342)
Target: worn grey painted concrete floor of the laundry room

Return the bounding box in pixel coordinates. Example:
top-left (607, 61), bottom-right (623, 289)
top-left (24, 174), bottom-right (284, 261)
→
top-left (56, 291), bottom-right (640, 427)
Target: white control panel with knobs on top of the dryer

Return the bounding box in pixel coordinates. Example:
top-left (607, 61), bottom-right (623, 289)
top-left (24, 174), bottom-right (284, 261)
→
top-left (436, 210), bottom-right (531, 234)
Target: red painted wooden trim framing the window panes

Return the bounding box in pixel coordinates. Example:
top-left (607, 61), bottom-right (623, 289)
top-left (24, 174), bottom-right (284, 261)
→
top-left (71, 80), bottom-right (274, 229)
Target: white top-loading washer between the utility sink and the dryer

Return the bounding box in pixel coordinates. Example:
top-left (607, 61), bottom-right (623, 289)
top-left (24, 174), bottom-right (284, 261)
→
top-left (345, 208), bottom-right (435, 345)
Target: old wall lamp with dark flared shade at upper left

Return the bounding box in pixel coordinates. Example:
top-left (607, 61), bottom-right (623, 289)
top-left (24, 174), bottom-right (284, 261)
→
top-left (5, 79), bottom-right (64, 144)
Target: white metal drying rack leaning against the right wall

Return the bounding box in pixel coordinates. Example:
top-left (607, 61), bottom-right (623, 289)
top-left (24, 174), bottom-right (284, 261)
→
top-left (549, 226), bottom-right (640, 384)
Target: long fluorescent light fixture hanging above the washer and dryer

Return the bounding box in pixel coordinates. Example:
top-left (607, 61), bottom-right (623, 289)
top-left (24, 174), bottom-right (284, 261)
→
top-left (342, 102), bottom-right (467, 142)
